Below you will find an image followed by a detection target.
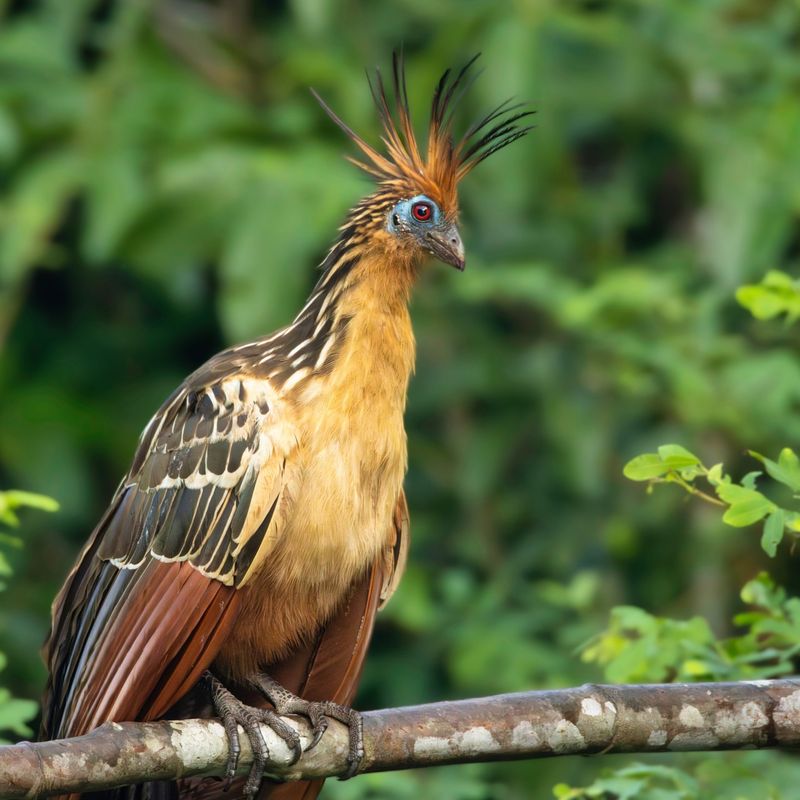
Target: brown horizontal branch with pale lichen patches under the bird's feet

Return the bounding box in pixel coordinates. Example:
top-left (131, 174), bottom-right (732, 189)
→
top-left (0, 679), bottom-right (800, 800)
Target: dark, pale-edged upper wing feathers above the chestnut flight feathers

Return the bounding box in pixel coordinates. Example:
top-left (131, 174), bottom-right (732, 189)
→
top-left (98, 377), bottom-right (294, 586)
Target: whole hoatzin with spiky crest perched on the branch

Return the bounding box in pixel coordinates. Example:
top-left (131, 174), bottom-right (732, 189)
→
top-left (41, 55), bottom-right (531, 800)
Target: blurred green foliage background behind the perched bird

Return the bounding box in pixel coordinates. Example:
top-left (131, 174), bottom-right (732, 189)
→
top-left (0, 0), bottom-right (800, 800)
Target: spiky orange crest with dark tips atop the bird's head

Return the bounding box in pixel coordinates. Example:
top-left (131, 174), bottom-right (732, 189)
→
top-left (311, 51), bottom-right (535, 216)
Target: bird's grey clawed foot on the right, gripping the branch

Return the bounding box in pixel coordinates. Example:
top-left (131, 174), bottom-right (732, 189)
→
top-left (251, 675), bottom-right (364, 781)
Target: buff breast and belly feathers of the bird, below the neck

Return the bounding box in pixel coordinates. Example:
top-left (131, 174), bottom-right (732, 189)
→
top-left (217, 409), bottom-right (406, 678)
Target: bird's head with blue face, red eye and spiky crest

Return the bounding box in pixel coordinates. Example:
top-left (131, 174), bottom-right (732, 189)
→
top-left (312, 52), bottom-right (534, 270)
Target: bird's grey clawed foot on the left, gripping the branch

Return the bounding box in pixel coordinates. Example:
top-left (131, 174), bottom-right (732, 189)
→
top-left (205, 672), bottom-right (303, 798)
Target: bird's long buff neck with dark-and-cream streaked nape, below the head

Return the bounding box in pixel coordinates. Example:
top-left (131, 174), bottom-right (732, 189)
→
top-left (262, 198), bottom-right (416, 396)
